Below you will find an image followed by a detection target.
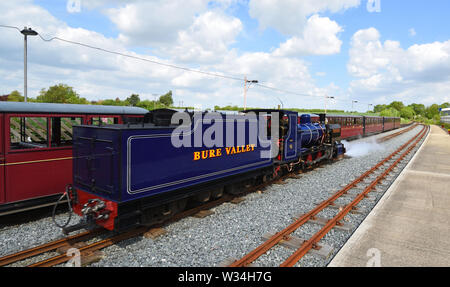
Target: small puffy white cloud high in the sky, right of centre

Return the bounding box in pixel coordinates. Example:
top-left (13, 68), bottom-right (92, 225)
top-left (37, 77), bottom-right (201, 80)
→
top-left (274, 15), bottom-right (343, 56)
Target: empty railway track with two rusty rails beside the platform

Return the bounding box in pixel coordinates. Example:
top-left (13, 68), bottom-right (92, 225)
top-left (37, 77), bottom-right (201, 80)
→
top-left (228, 126), bottom-right (428, 267)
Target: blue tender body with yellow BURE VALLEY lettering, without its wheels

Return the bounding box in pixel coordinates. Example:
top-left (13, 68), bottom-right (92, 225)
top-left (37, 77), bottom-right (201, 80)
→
top-left (73, 115), bottom-right (273, 202)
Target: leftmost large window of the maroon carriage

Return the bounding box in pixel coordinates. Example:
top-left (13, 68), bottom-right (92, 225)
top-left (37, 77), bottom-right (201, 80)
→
top-left (9, 117), bottom-right (48, 150)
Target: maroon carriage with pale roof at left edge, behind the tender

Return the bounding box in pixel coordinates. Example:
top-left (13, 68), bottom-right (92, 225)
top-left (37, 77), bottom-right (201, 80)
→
top-left (0, 102), bottom-right (148, 215)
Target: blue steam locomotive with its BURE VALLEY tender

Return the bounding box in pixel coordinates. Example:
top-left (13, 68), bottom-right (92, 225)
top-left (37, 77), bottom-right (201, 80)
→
top-left (65, 109), bottom-right (345, 232)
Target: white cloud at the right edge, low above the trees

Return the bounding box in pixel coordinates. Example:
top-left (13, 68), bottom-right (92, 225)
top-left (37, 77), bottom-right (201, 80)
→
top-left (347, 28), bottom-right (450, 104)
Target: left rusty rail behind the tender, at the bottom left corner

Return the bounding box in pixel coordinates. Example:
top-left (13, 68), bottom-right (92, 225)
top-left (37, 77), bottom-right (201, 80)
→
top-left (0, 229), bottom-right (102, 266)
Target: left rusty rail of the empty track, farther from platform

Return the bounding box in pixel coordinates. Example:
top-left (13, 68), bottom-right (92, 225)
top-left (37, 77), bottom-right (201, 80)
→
top-left (229, 127), bottom-right (425, 267)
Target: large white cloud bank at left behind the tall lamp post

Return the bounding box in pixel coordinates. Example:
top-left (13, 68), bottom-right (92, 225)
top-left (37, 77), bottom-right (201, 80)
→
top-left (0, 1), bottom-right (330, 111)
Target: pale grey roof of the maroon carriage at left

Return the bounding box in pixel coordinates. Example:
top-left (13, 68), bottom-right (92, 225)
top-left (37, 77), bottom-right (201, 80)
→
top-left (0, 102), bottom-right (148, 115)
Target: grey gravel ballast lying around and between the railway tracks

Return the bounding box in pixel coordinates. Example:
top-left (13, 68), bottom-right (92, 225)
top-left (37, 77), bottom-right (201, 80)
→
top-left (0, 127), bottom-right (428, 267)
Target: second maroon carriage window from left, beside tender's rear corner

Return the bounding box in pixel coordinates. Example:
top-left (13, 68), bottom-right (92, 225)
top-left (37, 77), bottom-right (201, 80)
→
top-left (51, 117), bottom-right (82, 147)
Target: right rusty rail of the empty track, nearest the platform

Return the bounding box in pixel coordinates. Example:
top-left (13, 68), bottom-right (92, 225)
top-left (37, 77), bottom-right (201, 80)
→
top-left (280, 125), bottom-right (428, 267)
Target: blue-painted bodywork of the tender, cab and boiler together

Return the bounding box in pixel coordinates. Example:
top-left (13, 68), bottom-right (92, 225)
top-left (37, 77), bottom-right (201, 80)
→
top-left (73, 111), bottom-right (344, 206)
